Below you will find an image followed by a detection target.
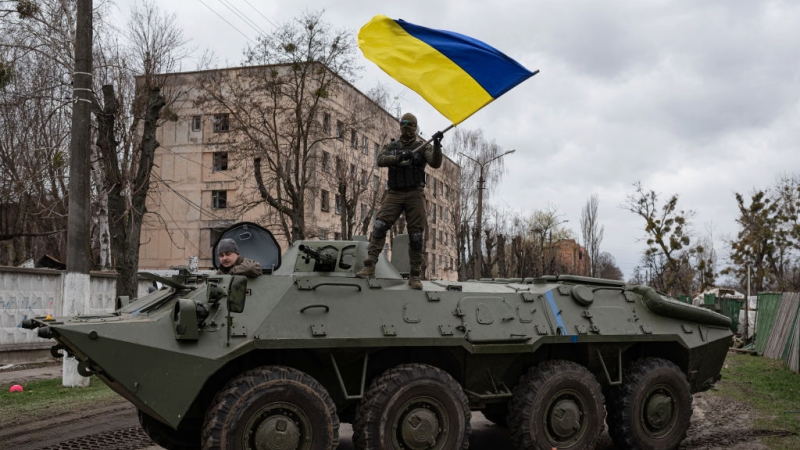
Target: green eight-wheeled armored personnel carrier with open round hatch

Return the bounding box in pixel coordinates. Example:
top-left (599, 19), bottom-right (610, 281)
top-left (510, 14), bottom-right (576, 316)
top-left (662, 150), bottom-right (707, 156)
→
top-left (23, 223), bottom-right (731, 450)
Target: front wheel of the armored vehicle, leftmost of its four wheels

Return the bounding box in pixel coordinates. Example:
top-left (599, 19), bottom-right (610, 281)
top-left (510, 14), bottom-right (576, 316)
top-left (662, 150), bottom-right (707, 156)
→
top-left (203, 366), bottom-right (339, 450)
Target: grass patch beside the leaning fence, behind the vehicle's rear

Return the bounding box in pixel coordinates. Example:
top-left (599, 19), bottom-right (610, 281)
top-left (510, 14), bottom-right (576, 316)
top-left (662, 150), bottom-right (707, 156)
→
top-left (709, 353), bottom-right (800, 450)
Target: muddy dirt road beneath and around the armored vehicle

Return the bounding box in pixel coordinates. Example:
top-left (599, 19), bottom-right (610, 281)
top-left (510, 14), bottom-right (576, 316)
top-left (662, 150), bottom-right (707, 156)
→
top-left (0, 386), bottom-right (781, 450)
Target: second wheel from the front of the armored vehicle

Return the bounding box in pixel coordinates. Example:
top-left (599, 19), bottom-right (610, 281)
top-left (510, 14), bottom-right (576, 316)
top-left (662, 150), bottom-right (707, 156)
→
top-left (353, 364), bottom-right (472, 450)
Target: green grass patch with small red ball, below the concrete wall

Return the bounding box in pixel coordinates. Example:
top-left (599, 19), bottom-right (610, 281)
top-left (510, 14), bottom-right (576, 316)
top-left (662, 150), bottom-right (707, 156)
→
top-left (0, 376), bottom-right (122, 427)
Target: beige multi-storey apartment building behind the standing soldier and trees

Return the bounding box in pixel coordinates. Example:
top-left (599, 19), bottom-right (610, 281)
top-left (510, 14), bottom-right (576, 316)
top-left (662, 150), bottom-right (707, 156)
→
top-left (139, 66), bottom-right (461, 280)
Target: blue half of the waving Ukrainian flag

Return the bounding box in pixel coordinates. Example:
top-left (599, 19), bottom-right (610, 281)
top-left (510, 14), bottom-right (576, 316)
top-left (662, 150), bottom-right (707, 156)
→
top-left (396, 19), bottom-right (533, 98)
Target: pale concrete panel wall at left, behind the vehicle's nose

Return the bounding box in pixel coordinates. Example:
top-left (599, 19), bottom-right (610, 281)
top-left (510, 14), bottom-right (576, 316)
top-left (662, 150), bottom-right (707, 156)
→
top-left (0, 267), bottom-right (151, 364)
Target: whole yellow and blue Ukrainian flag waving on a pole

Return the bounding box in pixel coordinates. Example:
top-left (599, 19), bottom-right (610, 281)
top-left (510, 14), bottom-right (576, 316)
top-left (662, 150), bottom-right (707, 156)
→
top-left (358, 15), bottom-right (538, 125)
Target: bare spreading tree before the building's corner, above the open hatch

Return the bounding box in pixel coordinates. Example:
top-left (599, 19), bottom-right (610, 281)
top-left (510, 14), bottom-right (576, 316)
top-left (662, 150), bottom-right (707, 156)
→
top-left (197, 12), bottom-right (357, 240)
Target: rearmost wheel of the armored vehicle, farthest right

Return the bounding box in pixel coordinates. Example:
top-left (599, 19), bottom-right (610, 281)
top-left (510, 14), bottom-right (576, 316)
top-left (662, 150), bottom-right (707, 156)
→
top-left (608, 358), bottom-right (692, 450)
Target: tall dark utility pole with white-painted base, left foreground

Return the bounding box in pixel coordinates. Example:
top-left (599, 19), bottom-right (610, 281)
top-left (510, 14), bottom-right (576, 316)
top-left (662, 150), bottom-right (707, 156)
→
top-left (62, 0), bottom-right (93, 387)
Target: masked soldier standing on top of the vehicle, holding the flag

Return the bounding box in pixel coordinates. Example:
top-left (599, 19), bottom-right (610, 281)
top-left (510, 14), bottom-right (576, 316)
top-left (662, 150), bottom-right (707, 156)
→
top-left (356, 113), bottom-right (443, 289)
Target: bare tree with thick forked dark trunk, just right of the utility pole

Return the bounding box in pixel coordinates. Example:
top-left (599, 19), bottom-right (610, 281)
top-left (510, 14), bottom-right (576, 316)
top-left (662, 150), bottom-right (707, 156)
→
top-left (94, 2), bottom-right (188, 297)
